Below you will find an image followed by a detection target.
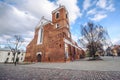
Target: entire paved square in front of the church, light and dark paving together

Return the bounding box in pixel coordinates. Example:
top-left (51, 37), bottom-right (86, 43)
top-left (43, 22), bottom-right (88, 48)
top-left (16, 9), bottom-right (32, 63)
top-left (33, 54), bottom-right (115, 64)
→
top-left (0, 57), bottom-right (120, 80)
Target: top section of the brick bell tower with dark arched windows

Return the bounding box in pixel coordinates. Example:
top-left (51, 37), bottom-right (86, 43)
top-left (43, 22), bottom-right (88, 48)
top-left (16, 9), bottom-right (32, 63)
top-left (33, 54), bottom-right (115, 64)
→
top-left (52, 6), bottom-right (69, 28)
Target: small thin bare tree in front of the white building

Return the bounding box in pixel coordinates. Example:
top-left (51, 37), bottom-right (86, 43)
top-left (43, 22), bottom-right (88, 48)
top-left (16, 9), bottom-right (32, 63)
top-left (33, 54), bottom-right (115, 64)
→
top-left (7, 35), bottom-right (24, 65)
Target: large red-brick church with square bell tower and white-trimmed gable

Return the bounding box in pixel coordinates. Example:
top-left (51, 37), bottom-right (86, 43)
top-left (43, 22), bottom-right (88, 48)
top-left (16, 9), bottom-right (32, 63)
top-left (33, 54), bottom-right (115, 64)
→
top-left (25, 6), bottom-right (85, 62)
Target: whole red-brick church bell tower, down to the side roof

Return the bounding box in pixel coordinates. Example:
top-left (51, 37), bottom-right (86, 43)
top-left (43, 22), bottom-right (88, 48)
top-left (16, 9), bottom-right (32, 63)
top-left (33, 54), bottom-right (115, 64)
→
top-left (52, 6), bottom-right (71, 38)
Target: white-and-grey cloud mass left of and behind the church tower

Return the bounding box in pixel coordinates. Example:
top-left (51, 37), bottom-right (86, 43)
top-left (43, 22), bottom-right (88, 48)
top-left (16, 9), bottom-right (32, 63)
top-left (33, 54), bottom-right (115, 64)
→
top-left (0, 0), bottom-right (81, 48)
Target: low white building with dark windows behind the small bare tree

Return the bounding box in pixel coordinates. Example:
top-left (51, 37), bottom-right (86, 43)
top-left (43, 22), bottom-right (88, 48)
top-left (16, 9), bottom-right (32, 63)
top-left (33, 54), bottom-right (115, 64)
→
top-left (0, 48), bottom-right (25, 63)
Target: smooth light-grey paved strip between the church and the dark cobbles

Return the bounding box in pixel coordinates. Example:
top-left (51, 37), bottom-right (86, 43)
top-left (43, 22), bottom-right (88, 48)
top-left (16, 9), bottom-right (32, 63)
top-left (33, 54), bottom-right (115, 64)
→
top-left (23, 56), bottom-right (120, 71)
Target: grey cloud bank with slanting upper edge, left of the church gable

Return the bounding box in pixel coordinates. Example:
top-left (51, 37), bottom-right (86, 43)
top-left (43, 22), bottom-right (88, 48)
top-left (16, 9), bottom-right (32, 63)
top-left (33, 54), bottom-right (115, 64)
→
top-left (0, 3), bottom-right (39, 36)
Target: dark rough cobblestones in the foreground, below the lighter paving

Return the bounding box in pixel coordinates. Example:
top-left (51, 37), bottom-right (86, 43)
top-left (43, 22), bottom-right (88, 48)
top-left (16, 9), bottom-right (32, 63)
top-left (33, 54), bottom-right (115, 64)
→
top-left (0, 64), bottom-right (120, 80)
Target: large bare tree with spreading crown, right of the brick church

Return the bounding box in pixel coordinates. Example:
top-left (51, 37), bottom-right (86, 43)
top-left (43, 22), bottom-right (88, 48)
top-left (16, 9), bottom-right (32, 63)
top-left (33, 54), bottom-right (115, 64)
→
top-left (78, 22), bottom-right (109, 60)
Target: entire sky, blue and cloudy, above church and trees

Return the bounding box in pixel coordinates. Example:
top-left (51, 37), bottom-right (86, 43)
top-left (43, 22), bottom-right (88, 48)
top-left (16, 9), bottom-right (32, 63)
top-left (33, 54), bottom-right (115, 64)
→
top-left (0, 0), bottom-right (120, 49)
